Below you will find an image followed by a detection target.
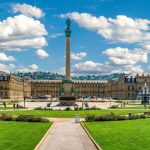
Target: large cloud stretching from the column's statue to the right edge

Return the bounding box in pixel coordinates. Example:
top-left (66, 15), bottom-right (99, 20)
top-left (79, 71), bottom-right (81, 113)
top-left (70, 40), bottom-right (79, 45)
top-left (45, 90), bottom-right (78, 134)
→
top-left (60, 12), bottom-right (150, 43)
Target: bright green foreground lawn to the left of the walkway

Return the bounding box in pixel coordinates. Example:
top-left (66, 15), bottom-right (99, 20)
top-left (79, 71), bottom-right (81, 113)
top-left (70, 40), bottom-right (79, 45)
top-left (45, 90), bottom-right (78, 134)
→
top-left (0, 121), bottom-right (52, 150)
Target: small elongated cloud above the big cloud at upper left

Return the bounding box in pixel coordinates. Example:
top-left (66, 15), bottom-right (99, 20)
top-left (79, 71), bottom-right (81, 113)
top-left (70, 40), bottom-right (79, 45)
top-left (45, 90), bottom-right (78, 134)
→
top-left (12, 3), bottom-right (44, 18)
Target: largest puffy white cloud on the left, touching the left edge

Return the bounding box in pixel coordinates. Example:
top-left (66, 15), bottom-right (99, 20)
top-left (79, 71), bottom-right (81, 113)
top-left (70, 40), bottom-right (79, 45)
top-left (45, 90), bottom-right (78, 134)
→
top-left (0, 15), bottom-right (47, 51)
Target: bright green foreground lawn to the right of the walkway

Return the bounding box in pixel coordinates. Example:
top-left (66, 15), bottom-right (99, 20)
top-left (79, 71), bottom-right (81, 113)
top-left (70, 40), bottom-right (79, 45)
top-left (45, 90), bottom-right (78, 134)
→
top-left (83, 119), bottom-right (150, 150)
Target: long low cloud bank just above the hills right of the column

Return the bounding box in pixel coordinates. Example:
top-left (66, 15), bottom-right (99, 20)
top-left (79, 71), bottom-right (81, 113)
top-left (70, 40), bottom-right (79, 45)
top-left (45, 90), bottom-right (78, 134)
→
top-left (72, 61), bottom-right (143, 75)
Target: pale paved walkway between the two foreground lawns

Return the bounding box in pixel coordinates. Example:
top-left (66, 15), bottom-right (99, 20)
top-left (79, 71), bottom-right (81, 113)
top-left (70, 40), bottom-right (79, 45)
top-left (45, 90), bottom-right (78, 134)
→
top-left (38, 118), bottom-right (96, 150)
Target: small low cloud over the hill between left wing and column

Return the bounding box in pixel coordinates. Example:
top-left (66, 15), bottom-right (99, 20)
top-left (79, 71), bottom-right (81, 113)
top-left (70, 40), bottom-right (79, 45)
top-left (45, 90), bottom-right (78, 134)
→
top-left (17, 64), bottom-right (39, 72)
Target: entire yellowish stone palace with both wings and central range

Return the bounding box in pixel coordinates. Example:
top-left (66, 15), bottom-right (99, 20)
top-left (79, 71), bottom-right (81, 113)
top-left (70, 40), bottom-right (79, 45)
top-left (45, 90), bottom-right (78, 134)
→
top-left (0, 72), bottom-right (150, 100)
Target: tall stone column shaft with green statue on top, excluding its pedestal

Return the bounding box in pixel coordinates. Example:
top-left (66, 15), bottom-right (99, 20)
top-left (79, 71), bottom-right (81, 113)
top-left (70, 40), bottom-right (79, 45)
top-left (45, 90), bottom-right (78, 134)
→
top-left (65, 18), bottom-right (71, 80)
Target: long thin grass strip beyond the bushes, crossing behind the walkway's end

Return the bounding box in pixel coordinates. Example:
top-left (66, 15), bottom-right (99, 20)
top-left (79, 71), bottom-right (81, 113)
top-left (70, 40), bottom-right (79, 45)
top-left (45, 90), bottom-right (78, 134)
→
top-left (0, 110), bottom-right (149, 118)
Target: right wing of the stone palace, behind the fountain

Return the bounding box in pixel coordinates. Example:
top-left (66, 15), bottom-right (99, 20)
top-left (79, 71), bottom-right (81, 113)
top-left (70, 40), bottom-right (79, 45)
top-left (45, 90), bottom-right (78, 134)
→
top-left (104, 73), bottom-right (150, 100)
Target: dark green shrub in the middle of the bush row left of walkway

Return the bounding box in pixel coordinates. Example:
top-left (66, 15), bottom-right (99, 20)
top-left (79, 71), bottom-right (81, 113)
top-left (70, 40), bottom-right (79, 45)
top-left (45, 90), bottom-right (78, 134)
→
top-left (16, 115), bottom-right (41, 122)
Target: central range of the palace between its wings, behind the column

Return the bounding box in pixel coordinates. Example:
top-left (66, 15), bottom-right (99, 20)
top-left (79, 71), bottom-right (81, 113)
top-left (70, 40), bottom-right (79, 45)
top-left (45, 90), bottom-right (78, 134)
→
top-left (31, 80), bottom-right (106, 98)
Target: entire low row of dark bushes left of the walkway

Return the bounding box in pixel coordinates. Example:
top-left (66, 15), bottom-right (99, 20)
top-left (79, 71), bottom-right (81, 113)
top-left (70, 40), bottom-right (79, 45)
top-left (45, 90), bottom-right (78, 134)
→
top-left (0, 113), bottom-right (49, 122)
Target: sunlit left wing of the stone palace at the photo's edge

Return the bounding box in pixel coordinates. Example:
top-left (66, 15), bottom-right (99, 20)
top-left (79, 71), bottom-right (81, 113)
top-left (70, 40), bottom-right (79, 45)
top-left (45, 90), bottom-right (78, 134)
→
top-left (0, 71), bottom-right (31, 99)
